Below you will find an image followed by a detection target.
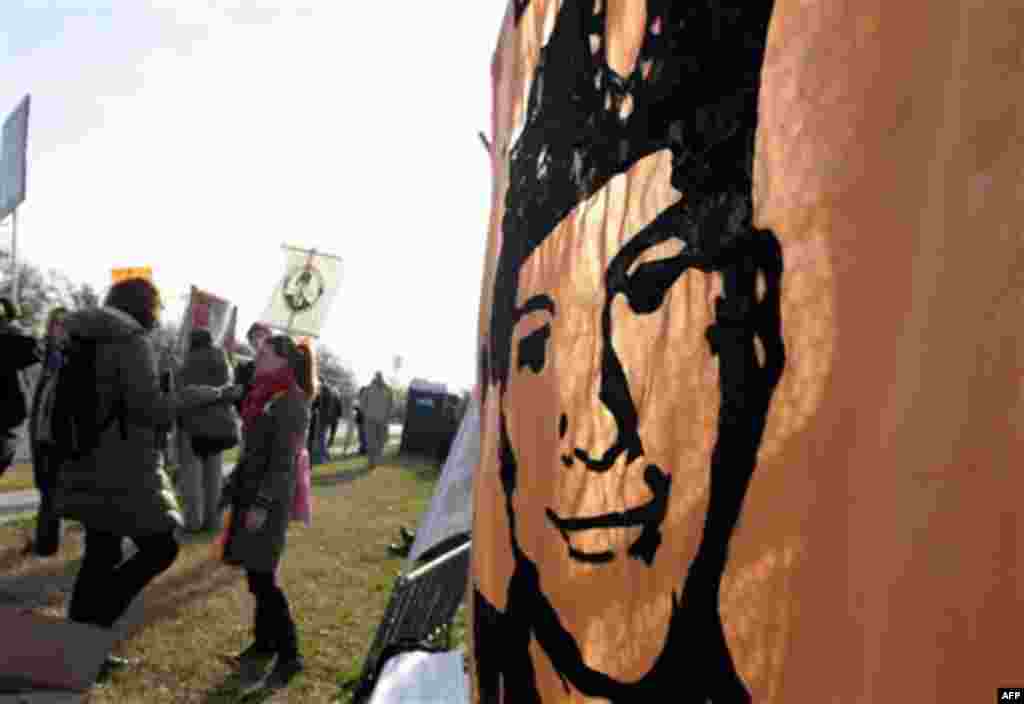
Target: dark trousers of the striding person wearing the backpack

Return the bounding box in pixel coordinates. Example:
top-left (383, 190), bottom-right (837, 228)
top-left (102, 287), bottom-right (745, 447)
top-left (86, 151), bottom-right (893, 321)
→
top-left (68, 527), bottom-right (178, 628)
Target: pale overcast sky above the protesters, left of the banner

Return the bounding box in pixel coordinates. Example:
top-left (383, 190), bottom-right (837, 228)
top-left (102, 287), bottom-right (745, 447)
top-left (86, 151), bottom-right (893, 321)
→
top-left (0, 0), bottom-right (506, 389)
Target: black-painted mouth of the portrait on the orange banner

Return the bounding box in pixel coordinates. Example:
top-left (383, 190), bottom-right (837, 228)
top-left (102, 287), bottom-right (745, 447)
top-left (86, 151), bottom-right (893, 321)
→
top-left (546, 465), bottom-right (672, 566)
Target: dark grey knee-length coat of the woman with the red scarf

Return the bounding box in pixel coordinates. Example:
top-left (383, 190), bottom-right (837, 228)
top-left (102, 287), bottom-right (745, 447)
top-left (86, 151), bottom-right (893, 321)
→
top-left (224, 389), bottom-right (310, 572)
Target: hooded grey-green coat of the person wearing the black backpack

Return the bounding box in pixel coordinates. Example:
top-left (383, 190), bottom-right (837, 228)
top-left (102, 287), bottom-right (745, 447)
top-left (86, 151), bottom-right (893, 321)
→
top-left (54, 307), bottom-right (220, 535)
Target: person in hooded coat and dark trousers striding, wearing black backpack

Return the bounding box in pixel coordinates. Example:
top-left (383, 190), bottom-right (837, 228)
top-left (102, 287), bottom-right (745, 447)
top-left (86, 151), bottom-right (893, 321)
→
top-left (54, 278), bottom-right (238, 676)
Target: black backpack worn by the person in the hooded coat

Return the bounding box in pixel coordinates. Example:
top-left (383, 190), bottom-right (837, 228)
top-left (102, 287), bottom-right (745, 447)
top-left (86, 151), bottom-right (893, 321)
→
top-left (36, 337), bottom-right (127, 467)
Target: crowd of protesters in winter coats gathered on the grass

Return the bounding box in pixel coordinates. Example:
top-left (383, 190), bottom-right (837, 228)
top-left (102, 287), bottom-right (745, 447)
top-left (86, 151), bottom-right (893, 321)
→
top-left (0, 278), bottom-right (393, 691)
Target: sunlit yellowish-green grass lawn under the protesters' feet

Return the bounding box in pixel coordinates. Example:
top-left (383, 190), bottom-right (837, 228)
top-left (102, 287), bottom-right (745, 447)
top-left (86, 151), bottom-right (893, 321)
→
top-left (0, 455), bottom-right (463, 704)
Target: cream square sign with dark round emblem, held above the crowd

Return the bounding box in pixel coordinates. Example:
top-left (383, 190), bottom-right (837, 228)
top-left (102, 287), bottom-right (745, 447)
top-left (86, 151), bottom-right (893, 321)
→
top-left (261, 247), bottom-right (341, 338)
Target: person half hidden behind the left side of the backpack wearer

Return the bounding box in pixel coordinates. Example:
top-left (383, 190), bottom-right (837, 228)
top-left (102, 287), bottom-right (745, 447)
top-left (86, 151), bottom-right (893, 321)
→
top-left (25, 306), bottom-right (68, 557)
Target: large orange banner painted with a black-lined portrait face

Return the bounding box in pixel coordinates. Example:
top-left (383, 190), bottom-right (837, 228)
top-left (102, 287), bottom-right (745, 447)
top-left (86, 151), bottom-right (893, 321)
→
top-left (469, 0), bottom-right (1024, 704)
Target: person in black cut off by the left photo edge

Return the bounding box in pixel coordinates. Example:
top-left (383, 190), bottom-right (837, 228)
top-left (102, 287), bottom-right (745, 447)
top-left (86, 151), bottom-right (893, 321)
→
top-left (0, 298), bottom-right (40, 475)
